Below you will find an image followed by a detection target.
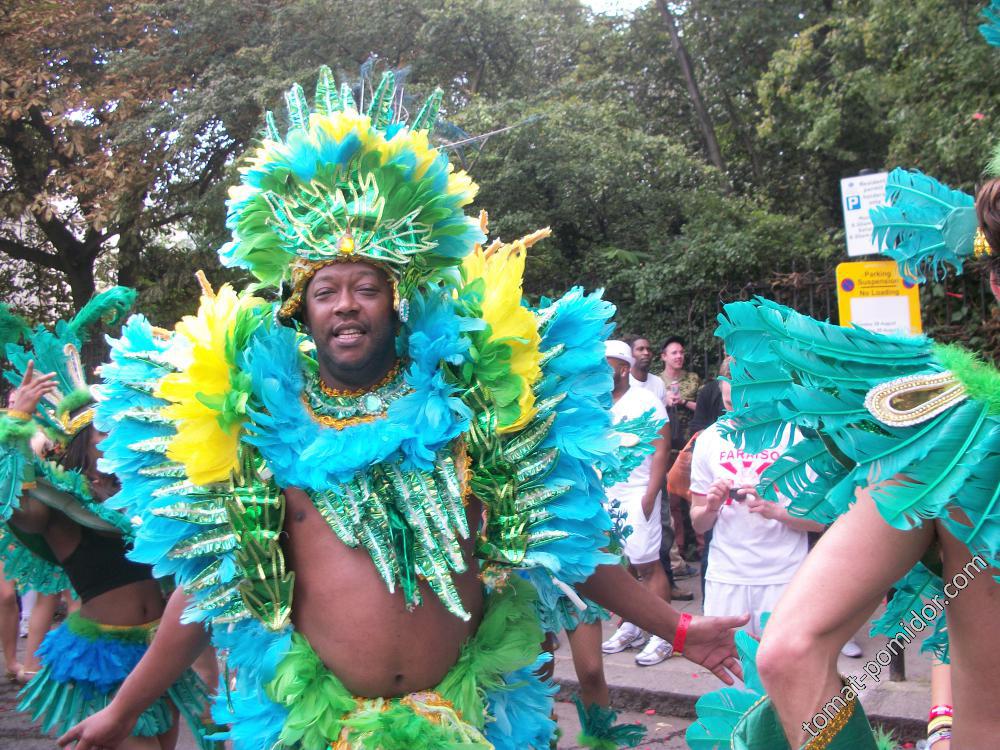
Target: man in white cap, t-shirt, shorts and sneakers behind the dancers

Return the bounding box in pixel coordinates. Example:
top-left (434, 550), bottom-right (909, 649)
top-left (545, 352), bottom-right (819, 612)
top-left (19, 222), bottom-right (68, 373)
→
top-left (601, 341), bottom-right (672, 666)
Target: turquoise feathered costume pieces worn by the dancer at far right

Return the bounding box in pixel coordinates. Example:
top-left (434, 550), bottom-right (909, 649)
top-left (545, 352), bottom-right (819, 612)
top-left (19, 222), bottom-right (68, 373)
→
top-left (689, 156), bottom-right (1000, 750)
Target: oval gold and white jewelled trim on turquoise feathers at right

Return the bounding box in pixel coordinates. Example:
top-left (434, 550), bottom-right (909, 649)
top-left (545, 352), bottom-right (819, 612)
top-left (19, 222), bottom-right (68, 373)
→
top-left (865, 371), bottom-right (968, 427)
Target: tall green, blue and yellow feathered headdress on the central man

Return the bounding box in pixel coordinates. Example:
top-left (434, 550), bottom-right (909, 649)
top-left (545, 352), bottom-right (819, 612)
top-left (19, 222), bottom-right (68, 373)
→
top-left (219, 66), bottom-right (484, 318)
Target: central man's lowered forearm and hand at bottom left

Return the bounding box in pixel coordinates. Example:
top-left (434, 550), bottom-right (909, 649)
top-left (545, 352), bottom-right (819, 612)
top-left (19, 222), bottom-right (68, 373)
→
top-left (57, 589), bottom-right (209, 750)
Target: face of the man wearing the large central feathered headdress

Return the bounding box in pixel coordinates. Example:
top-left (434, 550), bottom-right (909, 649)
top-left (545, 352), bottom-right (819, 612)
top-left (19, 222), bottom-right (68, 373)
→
top-left (303, 263), bottom-right (395, 384)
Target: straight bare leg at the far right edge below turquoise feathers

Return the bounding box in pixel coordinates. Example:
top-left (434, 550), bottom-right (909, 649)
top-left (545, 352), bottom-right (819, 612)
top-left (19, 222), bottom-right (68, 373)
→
top-left (934, 524), bottom-right (1000, 750)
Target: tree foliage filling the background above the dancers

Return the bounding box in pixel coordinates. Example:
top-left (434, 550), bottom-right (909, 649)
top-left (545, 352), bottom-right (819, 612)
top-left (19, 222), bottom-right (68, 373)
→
top-left (0, 0), bottom-right (1000, 368)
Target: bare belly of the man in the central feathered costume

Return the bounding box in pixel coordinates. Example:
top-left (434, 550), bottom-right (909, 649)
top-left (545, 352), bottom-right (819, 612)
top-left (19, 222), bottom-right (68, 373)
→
top-left (284, 489), bottom-right (483, 698)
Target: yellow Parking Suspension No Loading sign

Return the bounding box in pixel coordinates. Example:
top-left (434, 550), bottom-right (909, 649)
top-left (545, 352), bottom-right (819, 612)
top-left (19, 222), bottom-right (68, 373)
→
top-left (837, 260), bottom-right (923, 335)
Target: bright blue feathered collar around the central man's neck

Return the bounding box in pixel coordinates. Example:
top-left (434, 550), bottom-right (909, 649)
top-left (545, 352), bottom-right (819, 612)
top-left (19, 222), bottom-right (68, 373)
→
top-left (241, 289), bottom-right (480, 491)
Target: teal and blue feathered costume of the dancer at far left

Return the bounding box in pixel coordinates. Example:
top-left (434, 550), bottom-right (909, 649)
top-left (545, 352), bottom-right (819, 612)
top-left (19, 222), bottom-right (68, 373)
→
top-left (0, 287), bottom-right (214, 748)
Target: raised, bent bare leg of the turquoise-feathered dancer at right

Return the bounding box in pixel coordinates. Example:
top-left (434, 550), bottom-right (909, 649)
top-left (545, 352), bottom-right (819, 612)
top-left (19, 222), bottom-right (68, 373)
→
top-left (757, 492), bottom-right (934, 747)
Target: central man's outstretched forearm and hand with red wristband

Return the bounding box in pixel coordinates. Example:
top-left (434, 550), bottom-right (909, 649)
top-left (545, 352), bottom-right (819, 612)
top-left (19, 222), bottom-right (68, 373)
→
top-left (576, 565), bottom-right (750, 685)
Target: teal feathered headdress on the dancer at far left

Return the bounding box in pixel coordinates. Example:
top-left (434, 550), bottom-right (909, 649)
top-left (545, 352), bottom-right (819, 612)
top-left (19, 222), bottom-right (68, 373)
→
top-left (0, 286), bottom-right (135, 440)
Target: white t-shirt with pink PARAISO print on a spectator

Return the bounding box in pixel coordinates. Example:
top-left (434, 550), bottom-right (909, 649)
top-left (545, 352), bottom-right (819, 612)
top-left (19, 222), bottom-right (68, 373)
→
top-left (691, 422), bottom-right (809, 586)
